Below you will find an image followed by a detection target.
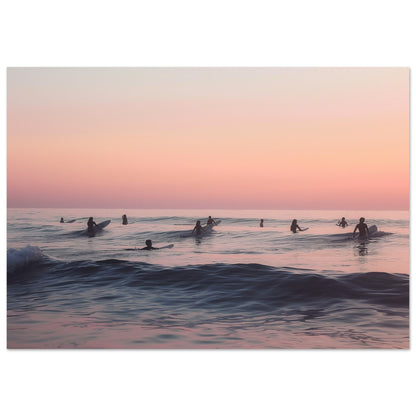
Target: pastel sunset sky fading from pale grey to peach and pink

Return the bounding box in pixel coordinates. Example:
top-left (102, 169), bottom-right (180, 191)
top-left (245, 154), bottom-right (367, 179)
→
top-left (7, 68), bottom-right (409, 210)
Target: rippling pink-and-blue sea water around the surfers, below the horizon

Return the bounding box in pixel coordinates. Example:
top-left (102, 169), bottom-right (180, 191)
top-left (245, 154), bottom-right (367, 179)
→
top-left (7, 209), bottom-right (409, 349)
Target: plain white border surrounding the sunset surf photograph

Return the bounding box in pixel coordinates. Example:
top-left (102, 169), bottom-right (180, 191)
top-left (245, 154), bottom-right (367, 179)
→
top-left (0, 0), bottom-right (416, 416)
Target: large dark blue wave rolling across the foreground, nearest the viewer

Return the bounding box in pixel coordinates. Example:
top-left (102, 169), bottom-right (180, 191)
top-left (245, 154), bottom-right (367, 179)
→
top-left (8, 258), bottom-right (409, 310)
